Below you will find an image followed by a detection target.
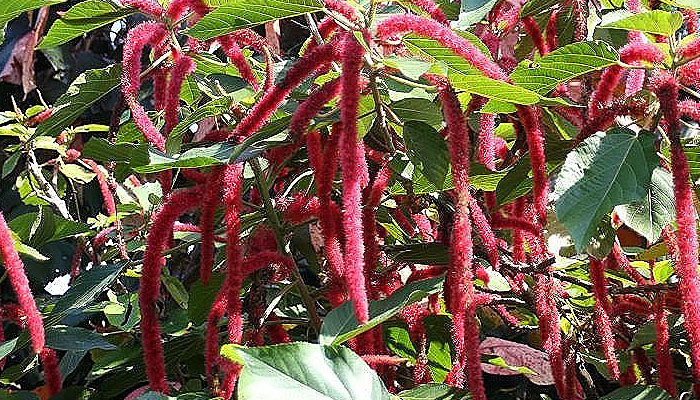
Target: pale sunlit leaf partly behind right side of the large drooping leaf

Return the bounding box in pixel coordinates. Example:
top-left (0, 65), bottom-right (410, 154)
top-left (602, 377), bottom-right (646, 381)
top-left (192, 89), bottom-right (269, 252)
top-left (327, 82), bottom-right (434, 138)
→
top-left (615, 167), bottom-right (676, 243)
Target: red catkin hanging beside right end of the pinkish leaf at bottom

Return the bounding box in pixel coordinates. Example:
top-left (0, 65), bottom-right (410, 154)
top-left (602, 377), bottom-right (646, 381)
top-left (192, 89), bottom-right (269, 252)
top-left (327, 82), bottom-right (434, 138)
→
top-left (535, 274), bottom-right (567, 398)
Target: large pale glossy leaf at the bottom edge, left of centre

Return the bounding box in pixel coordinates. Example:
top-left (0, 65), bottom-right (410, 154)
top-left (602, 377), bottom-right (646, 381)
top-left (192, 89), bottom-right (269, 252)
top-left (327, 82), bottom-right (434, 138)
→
top-left (221, 343), bottom-right (390, 400)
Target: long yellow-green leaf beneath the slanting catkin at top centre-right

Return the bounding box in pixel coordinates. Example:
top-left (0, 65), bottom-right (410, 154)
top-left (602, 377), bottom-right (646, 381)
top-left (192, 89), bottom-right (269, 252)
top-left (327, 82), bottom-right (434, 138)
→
top-left (403, 32), bottom-right (540, 104)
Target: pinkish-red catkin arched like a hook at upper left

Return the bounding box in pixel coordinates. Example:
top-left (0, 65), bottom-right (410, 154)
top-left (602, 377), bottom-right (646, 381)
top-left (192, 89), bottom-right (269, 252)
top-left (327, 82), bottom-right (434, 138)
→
top-left (122, 22), bottom-right (167, 150)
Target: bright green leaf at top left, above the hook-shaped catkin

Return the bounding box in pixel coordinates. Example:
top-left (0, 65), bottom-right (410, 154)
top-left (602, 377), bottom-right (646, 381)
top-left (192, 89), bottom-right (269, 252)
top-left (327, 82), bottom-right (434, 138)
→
top-left (37, 0), bottom-right (135, 49)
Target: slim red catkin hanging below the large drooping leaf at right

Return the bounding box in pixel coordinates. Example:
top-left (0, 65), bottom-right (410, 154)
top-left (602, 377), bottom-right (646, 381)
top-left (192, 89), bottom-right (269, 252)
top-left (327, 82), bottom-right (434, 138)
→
top-left (589, 257), bottom-right (620, 380)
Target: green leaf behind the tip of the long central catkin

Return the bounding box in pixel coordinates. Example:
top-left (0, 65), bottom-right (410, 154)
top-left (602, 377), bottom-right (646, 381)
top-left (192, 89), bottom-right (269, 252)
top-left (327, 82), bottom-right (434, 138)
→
top-left (318, 276), bottom-right (444, 345)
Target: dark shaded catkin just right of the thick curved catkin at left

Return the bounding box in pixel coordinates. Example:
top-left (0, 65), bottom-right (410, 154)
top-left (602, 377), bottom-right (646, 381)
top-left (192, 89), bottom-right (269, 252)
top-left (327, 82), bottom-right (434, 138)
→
top-left (199, 167), bottom-right (223, 285)
